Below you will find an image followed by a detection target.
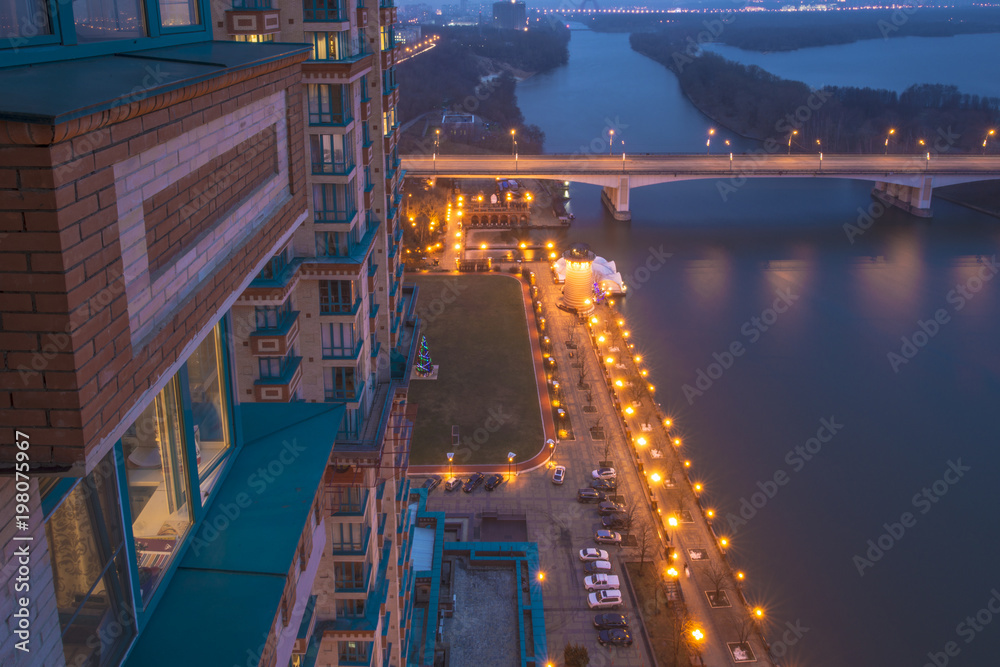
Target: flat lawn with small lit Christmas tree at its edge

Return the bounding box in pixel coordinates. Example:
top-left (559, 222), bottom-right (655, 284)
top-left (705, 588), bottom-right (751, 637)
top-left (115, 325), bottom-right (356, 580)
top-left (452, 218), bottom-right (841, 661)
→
top-left (406, 274), bottom-right (544, 465)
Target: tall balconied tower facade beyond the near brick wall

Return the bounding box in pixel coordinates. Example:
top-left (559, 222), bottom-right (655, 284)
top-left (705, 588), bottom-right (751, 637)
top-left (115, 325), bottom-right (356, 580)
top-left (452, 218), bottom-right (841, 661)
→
top-left (213, 0), bottom-right (416, 667)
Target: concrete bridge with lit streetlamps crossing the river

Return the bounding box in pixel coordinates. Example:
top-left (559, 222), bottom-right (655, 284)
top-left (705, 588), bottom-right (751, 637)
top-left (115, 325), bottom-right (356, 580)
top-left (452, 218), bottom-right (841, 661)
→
top-left (402, 153), bottom-right (1000, 220)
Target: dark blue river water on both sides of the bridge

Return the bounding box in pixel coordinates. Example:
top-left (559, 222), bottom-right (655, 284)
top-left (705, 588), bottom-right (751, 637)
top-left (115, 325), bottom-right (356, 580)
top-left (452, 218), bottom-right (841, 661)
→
top-left (518, 31), bottom-right (1000, 667)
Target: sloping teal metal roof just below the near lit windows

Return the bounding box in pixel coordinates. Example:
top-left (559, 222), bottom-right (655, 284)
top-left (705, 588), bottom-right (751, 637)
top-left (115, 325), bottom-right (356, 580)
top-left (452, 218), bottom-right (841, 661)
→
top-left (125, 403), bottom-right (345, 667)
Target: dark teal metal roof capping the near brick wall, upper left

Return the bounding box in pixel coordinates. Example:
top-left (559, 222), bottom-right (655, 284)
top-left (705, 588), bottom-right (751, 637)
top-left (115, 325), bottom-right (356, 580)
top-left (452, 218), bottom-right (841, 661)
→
top-left (0, 42), bottom-right (309, 124)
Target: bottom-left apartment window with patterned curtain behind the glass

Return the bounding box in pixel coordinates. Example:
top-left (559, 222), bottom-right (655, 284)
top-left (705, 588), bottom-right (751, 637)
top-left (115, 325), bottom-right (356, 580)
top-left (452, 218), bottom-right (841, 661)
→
top-left (46, 451), bottom-right (135, 666)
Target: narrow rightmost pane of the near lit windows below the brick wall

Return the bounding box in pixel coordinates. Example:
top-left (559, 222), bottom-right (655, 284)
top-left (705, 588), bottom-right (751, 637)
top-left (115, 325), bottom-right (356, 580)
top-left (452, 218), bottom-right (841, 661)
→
top-left (187, 327), bottom-right (232, 499)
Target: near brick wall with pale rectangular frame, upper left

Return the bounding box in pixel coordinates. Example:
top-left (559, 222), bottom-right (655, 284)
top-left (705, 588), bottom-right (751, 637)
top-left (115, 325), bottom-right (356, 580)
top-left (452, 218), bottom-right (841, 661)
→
top-left (0, 54), bottom-right (306, 474)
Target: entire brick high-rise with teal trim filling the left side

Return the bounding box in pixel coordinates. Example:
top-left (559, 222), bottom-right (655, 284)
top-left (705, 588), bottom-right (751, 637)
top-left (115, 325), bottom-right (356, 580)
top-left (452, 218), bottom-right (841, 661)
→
top-left (0, 0), bottom-right (418, 667)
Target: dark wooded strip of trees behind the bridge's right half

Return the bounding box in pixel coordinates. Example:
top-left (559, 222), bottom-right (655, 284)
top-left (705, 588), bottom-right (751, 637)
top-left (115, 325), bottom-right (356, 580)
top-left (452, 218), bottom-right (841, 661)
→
top-left (630, 33), bottom-right (1000, 153)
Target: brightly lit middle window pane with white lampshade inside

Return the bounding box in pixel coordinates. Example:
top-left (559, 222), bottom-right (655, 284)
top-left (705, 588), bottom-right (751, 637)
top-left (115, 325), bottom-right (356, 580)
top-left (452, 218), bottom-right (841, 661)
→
top-left (122, 377), bottom-right (191, 604)
